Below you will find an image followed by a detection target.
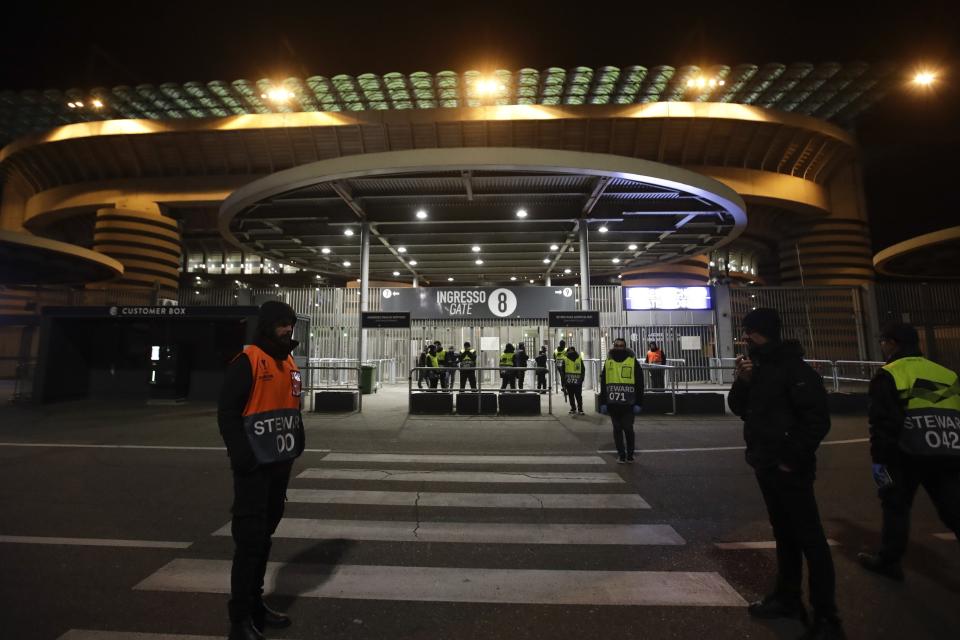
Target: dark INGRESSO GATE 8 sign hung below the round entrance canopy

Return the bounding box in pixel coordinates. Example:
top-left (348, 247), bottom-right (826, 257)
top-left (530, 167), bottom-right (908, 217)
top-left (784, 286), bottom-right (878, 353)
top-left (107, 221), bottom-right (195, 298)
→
top-left (380, 287), bottom-right (576, 320)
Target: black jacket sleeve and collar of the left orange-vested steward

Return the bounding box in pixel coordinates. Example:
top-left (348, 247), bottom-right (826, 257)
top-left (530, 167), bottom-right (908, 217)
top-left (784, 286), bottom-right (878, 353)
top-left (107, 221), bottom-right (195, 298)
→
top-left (217, 312), bottom-right (299, 473)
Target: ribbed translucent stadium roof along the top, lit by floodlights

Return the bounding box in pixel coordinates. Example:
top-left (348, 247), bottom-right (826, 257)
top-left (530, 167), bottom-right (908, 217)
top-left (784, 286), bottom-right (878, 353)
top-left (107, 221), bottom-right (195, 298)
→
top-left (0, 62), bottom-right (898, 145)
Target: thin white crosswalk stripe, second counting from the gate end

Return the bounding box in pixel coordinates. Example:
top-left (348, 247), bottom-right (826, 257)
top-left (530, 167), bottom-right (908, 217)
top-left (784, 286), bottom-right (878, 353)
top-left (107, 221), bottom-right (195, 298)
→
top-left (297, 469), bottom-right (623, 484)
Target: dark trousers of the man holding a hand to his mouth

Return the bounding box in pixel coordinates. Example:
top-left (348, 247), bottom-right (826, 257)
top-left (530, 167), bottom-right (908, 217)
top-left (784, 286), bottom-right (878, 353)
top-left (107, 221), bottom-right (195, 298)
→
top-left (756, 467), bottom-right (837, 617)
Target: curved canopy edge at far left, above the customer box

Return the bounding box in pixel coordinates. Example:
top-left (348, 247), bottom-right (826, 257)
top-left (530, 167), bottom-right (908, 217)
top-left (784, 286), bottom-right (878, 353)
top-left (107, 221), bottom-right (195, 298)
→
top-left (0, 231), bottom-right (123, 285)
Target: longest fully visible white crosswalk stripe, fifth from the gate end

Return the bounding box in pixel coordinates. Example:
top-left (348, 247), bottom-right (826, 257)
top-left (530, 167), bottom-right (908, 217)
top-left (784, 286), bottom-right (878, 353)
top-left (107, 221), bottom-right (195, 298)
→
top-left (135, 559), bottom-right (746, 607)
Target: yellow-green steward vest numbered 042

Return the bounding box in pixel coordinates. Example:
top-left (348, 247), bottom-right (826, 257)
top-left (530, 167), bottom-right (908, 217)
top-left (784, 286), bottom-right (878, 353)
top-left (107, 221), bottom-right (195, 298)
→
top-left (883, 356), bottom-right (960, 459)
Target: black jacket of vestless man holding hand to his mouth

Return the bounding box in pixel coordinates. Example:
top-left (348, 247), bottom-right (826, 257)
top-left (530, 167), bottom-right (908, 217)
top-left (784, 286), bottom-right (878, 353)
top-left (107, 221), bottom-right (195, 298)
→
top-left (727, 340), bottom-right (830, 469)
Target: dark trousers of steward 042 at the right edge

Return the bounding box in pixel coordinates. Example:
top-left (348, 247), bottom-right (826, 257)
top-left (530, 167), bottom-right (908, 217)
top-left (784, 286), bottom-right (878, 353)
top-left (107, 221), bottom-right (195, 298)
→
top-left (879, 459), bottom-right (960, 562)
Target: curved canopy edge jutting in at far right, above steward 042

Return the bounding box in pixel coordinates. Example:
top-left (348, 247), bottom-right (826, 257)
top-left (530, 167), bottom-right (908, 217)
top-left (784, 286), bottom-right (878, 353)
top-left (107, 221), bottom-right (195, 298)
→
top-left (873, 226), bottom-right (960, 279)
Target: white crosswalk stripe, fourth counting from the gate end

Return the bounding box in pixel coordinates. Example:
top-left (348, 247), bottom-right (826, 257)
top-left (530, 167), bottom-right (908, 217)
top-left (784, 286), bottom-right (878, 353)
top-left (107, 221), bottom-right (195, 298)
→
top-left (214, 518), bottom-right (684, 545)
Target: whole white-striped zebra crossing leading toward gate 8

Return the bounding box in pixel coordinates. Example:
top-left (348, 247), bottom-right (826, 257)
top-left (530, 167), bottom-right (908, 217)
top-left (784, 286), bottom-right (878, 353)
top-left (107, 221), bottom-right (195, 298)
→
top-left (61, 452), bottom-right (746, 640)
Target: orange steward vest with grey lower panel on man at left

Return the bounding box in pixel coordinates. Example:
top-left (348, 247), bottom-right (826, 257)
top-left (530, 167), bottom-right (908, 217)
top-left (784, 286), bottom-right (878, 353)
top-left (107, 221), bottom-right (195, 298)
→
top-left (243, 345), bottom-right (304, 464)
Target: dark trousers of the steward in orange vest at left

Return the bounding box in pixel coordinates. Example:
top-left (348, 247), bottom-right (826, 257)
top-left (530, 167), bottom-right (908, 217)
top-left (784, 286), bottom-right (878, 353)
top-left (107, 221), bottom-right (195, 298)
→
top-left (228, 462), bottom-right (293, 622)
